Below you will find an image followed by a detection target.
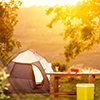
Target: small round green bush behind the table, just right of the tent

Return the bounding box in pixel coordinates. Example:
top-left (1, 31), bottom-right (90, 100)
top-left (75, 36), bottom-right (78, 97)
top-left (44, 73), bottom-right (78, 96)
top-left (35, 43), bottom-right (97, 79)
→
top-left (52, 61), bottom-right (68, 71)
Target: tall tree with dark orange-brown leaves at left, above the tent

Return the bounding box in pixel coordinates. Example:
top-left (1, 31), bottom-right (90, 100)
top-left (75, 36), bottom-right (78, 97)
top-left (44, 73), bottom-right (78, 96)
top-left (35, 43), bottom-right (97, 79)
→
top-left (0, 0), bottom-right (21, 61)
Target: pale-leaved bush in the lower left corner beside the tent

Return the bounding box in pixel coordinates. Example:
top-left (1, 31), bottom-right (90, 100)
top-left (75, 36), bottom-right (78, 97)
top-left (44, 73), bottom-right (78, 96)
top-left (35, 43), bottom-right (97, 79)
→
top-left (0, 67), bottom-right (10, 100)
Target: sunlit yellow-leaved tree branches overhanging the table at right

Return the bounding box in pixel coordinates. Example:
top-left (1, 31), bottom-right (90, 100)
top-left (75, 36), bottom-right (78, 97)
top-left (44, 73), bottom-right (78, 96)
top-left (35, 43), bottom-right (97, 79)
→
top-left (46, 0), bottom-right (100, 62)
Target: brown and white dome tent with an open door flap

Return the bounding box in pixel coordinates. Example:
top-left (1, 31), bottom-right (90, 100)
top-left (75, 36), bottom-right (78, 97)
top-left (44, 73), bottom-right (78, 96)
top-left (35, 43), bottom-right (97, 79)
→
top-left (7, 50), bottom-right (53, 93)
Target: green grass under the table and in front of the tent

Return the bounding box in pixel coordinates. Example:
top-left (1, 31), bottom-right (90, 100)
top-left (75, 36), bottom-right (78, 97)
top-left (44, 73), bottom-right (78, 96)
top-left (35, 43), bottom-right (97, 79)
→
top-left (9, 77), bottom-right (100, 100)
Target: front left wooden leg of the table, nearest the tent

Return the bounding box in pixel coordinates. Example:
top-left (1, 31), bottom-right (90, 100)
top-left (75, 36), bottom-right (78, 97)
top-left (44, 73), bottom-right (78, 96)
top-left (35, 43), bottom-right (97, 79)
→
top-left (50, 75), bottom-right (55, 98)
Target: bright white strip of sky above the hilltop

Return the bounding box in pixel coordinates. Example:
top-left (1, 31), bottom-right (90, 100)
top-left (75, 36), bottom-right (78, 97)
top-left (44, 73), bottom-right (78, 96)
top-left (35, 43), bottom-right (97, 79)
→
top-left (20, 0), bottom-right (83, 7)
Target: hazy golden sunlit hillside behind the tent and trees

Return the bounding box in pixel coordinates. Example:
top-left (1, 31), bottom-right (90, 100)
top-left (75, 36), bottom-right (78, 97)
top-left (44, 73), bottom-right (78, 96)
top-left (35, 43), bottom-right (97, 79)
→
top-left (14, 6), bottom-right (100, 69)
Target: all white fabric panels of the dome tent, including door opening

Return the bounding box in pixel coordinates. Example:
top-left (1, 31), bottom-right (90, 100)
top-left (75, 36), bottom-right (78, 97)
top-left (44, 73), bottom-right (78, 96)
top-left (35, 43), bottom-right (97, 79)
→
top-left (13, 50), bottom-right (53, 83)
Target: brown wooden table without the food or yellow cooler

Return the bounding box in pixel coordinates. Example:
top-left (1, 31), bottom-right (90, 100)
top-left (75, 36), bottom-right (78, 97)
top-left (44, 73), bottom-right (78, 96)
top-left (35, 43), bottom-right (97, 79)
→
top-left (46, 72), bottom-right (100, 98)
